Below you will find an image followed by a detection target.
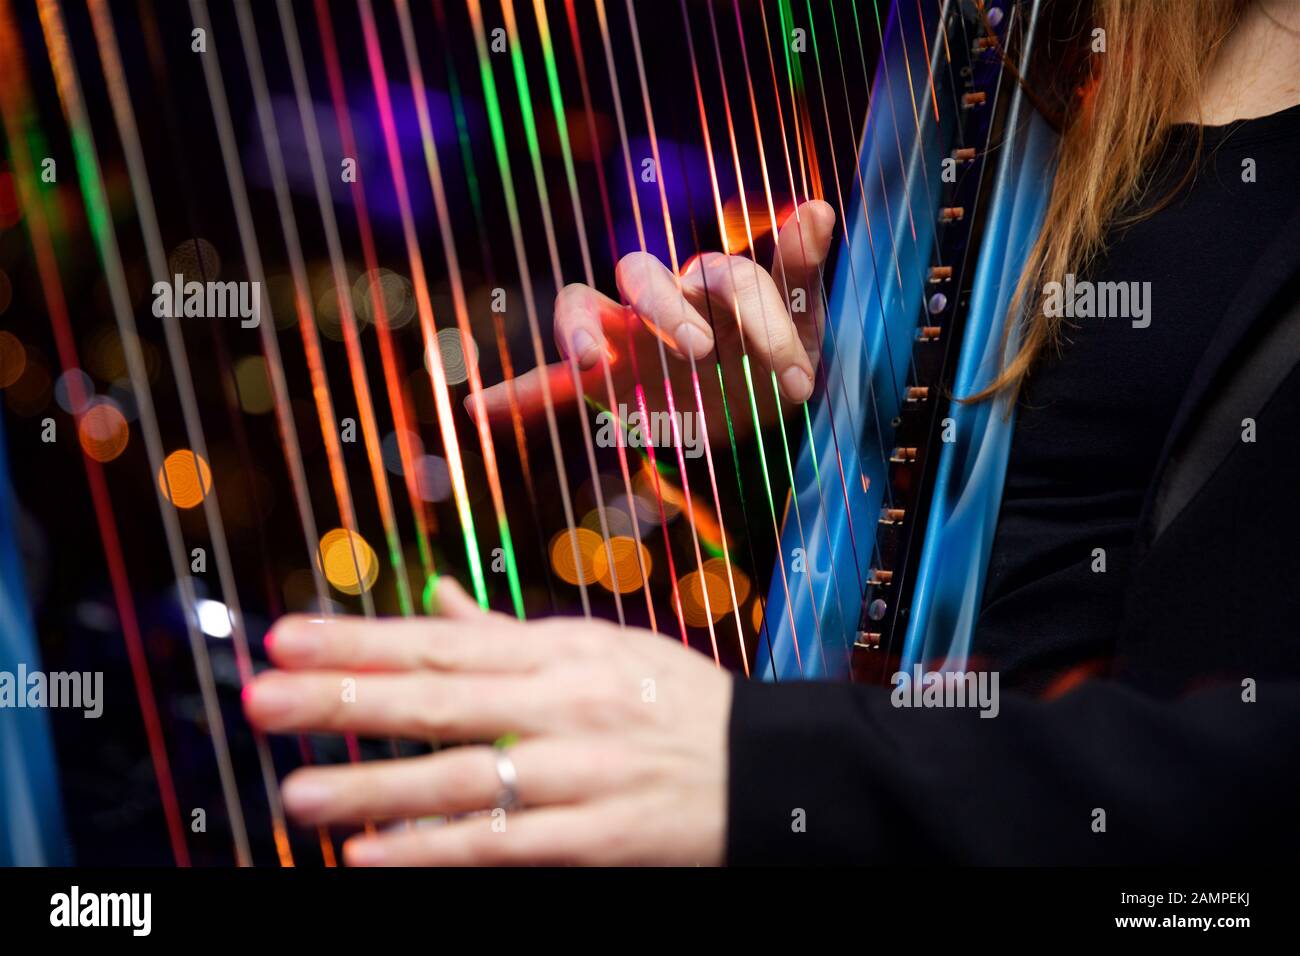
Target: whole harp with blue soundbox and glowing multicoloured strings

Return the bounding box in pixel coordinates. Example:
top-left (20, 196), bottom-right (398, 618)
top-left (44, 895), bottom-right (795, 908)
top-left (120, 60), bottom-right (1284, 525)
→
top-left (0, 0), bottom-right (1052, 865)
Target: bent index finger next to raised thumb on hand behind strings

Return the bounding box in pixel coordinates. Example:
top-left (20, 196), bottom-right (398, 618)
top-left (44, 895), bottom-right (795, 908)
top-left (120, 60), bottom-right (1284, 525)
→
top-left (683, 252), bottom-right (813, 402)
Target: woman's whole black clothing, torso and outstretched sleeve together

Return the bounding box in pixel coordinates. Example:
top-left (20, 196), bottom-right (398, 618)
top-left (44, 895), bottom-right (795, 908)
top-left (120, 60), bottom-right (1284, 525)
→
top-left (728, 108), bottom-right (1300, 864)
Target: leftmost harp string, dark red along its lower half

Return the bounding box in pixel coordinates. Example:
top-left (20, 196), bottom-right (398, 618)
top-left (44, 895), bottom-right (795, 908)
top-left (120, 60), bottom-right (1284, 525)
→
top-left (0, 0), bottom-right (190, 866)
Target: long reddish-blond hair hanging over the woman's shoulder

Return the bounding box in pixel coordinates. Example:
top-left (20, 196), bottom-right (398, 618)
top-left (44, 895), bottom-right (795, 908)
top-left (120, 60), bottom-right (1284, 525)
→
top-left (965, 0), bottom-right (1249, 402)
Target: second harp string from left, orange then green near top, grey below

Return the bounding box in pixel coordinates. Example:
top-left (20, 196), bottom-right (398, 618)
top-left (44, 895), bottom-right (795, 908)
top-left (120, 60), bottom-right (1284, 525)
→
top-left (38, 0), bottom-right (261, 866)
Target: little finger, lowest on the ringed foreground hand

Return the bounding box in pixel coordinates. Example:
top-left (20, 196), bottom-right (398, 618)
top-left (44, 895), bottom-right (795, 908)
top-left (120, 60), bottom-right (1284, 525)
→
top-left (343, 805), bottom-right (618, 866)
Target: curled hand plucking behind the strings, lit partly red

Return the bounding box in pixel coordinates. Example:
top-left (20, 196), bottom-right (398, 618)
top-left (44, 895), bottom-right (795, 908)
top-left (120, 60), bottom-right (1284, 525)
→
top-left (465, 199), bottom-right (835, 438)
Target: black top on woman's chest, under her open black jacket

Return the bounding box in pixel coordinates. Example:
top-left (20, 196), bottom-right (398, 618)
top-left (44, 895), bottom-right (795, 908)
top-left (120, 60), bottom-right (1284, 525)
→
top-left (972, 105), bottom-right (1300, 688)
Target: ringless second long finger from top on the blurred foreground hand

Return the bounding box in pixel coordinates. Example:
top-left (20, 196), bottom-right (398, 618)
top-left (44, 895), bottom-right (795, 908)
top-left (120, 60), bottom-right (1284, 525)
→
top-left (243, 671), bottom-right (538, 740)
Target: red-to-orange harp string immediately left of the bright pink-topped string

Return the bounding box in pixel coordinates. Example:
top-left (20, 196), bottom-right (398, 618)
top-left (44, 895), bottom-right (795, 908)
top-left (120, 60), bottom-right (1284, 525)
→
top-left (311, 3), bottom-right (437, 593)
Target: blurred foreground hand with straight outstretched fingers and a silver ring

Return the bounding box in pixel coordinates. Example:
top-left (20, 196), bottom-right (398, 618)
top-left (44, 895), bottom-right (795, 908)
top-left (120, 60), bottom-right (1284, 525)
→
top-left (244, 578), bottom-right (732, 866)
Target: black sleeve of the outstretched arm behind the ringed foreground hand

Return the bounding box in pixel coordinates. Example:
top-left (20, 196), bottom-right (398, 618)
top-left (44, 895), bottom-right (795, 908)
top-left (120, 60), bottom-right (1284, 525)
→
top-left (727, 680), bottom-right (1300, 864)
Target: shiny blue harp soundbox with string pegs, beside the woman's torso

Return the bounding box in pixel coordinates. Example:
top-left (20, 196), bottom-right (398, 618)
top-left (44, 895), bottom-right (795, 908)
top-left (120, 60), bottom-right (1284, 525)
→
top-left (766, 3), bottom-right (1053, 682)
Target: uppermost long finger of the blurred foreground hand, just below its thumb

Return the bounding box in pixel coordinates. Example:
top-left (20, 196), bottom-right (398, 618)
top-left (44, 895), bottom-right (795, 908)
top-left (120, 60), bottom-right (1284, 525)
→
top-left (265, 607), bottom-right (546, 674)
